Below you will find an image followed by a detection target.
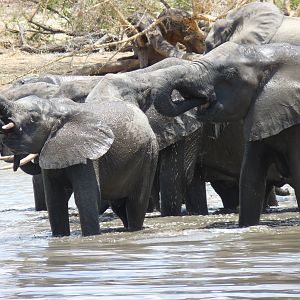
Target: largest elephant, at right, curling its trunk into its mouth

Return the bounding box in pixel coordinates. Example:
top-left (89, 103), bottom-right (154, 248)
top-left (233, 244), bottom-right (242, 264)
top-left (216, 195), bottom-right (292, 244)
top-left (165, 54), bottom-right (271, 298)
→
top-left (155, 42), bottom-right (300, 226)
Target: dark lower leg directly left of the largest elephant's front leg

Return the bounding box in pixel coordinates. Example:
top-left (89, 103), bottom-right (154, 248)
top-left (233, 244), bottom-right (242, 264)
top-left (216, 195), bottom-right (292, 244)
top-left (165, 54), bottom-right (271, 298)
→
top-left (210, 180), bottom-right (239, 210)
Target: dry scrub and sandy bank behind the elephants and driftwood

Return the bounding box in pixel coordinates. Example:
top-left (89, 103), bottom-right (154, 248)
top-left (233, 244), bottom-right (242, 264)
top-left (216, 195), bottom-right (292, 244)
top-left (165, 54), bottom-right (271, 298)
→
top-left (0, 0), bottom-right (300, 89)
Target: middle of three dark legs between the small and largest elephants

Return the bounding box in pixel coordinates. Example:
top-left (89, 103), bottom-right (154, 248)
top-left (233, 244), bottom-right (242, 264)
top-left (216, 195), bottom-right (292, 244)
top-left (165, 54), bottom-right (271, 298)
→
top-left (186, 169), bottom-right (208, 215)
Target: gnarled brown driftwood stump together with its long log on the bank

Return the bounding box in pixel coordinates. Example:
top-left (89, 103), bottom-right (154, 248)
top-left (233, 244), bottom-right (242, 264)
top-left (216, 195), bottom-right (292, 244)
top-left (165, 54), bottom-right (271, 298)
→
top-left (72, 8), bottom-right (205, 75)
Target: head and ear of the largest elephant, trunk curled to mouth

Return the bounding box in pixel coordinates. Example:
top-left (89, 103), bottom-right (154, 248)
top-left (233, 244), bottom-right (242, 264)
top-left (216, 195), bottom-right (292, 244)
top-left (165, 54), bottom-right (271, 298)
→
top-left (155, 42), bottom-right (300, 140)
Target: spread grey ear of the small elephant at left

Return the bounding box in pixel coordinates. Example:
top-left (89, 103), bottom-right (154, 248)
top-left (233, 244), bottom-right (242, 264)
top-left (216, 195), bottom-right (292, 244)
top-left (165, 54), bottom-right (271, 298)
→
top-left (39, 111), bottom-right (114, 169)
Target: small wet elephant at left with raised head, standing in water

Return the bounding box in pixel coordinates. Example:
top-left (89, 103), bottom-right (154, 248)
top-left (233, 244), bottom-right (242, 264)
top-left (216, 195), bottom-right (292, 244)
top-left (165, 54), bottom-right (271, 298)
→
top-left (0, 96), bottom-right (158, 236)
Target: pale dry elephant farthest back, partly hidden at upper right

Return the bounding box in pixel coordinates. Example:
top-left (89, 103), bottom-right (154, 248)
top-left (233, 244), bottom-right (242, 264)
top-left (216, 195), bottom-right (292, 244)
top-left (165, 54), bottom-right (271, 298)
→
top-left (205, 2), bottom-right (300, 53)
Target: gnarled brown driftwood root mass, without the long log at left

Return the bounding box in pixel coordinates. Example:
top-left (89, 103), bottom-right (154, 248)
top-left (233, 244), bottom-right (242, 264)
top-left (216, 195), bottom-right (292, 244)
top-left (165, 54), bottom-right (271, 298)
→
top-left (129, 8), bottom-right (205, 68)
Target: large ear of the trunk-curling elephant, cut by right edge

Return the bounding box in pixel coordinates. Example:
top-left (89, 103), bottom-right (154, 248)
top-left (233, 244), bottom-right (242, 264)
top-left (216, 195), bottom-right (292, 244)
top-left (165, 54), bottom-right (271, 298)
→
top-left (244, 66), bottom-right (300, 141)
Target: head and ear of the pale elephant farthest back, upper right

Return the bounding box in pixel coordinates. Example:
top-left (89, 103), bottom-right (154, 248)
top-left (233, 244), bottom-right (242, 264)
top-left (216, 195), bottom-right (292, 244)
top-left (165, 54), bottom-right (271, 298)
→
top-left (205, 2), bottom-right (283, 52)
